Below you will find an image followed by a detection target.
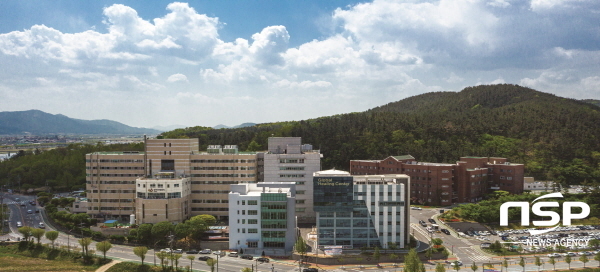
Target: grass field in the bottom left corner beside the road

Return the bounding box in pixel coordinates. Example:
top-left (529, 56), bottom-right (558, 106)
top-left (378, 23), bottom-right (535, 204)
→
top-left (0, 242), bottom-right (101, 272)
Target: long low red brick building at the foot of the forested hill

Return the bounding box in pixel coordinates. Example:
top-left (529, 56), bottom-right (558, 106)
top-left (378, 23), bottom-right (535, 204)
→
top-left (350, 155), bottom-right (524, 206)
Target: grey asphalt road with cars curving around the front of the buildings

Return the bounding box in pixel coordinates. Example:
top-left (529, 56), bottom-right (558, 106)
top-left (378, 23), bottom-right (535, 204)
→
top-left (4, 195), bottom-right (599, 272)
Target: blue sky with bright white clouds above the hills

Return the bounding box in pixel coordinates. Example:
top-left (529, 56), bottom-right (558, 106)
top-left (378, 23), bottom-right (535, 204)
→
top-left (0, 0), bottom-right (600, 127)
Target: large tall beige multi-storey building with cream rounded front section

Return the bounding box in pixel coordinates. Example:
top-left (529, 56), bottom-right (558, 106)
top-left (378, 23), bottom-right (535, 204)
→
top-left (86, 139), bottom-right (257, 224)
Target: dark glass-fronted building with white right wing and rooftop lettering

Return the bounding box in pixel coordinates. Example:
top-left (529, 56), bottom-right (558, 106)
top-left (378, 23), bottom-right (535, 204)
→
top-left (313, 170), bottom-right (410, 249)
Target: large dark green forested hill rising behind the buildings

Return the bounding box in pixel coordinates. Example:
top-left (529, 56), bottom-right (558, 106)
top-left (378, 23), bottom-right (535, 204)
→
top-left (163, 84), bottom-right (600, 183)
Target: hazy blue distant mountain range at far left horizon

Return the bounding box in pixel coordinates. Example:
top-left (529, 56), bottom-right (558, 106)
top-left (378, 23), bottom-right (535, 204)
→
top-left (0, 110), bottom-right (160, 135)
